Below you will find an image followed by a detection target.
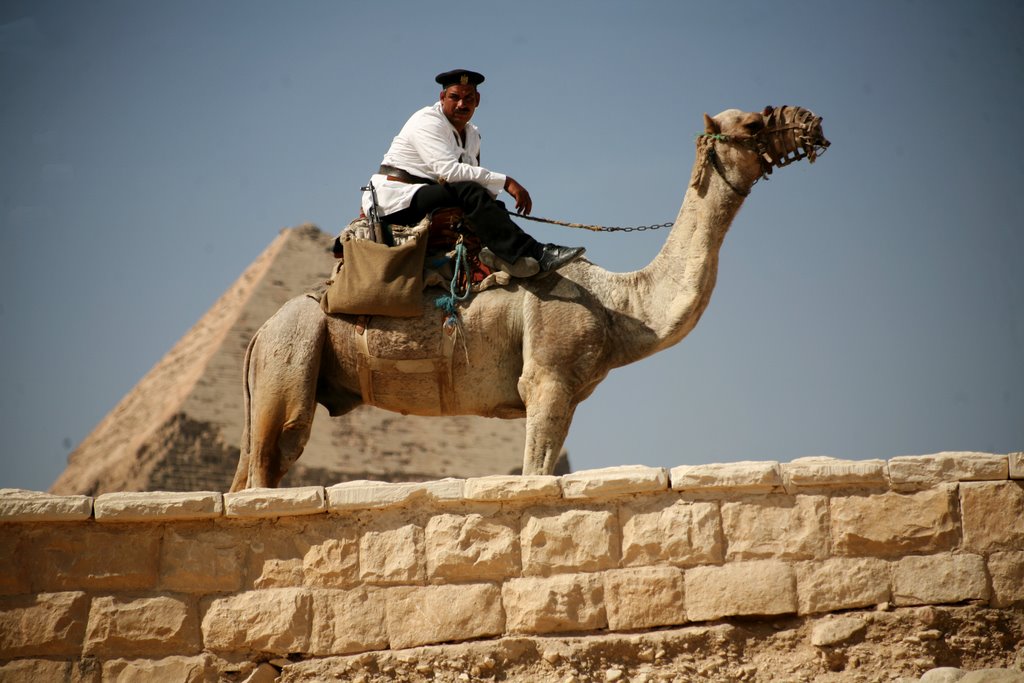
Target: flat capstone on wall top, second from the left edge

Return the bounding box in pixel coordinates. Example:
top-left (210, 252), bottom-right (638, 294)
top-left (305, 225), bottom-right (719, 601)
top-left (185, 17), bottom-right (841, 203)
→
top-left (93, 490), bottom-right (224, 522)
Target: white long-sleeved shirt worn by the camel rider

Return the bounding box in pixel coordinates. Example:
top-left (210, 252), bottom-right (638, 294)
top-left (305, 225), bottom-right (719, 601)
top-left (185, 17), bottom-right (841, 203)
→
top-left (362, 102), bottom-right (505, 216)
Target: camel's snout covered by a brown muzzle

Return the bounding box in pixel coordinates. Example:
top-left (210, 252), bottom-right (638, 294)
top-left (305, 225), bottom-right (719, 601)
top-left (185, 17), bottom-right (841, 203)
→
top-left (754, 104), bottom-right (830, 175)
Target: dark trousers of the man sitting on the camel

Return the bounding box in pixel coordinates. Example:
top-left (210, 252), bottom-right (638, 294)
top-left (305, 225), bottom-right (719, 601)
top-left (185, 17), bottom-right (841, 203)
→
top-left (381, 180), bottom-right (541, 263)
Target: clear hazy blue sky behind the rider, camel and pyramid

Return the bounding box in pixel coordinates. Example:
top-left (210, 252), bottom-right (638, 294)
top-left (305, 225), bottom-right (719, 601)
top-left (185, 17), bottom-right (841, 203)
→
top-left (0, 0), bottom-right (1024, 489)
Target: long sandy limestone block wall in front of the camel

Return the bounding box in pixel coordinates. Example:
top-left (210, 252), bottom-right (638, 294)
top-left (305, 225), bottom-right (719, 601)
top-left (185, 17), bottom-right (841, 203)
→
top-left (0, 453), bottom-right (1024, 681)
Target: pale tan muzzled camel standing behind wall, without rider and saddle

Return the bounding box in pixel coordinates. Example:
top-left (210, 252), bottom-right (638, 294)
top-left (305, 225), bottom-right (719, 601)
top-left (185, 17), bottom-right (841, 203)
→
top-left (230, 106), bottom-right (828, 492)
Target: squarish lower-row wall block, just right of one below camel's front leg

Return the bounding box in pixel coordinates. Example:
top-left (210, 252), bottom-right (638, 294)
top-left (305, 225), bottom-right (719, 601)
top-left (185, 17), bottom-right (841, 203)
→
top-left (603, 566), bottom-right (686, 631)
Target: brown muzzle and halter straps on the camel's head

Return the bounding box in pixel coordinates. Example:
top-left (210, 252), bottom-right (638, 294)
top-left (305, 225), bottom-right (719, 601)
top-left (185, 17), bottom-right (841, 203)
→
top-left (691, 104), bottom-right (831, 197)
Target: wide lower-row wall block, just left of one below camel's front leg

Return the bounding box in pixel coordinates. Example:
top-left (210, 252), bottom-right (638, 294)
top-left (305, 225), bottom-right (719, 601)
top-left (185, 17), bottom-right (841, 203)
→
top-left (387, 584), bottom-right (505, 649)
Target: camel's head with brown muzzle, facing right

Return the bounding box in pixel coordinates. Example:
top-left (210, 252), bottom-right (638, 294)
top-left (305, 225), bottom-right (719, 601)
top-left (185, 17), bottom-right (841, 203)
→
top-left (697, 105), bottom-right (830, 193)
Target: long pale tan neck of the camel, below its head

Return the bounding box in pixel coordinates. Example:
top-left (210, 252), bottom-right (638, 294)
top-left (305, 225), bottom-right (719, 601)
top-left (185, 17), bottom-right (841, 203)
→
top-left (598, 153), bottom-right (743, 365)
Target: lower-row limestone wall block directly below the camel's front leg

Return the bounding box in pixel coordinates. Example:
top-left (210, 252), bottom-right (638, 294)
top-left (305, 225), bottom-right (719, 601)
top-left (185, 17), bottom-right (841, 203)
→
top-left (502, 573), bottom-right (608, 633)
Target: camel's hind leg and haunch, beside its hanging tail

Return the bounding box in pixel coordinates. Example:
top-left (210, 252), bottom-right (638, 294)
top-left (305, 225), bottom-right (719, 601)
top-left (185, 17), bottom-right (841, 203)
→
top-left (231, 297), bottom-right (326, 490)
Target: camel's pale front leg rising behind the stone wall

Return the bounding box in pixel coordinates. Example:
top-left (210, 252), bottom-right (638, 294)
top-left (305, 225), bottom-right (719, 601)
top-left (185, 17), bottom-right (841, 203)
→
top-left (520, 380), bottom-right (577, 474)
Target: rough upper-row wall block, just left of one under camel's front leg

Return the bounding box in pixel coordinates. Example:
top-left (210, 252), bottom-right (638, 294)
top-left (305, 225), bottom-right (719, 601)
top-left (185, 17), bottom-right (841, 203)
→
top-left (425, 514), bottom-right (519, 581)
